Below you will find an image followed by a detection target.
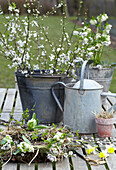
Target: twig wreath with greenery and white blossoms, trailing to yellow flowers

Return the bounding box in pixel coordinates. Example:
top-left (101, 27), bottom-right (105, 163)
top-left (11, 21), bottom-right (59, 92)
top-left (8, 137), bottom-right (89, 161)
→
top-left (0, 109), bottom-right (115, 167)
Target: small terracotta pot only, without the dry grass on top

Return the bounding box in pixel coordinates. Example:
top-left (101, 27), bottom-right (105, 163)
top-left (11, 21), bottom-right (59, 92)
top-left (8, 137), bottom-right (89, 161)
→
top-left (96, 118), bottom-right (114, 137)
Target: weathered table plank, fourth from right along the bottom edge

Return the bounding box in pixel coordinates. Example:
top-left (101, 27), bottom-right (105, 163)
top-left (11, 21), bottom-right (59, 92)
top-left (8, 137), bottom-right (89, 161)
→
top-left (56, 158), bottom-right (70, 170)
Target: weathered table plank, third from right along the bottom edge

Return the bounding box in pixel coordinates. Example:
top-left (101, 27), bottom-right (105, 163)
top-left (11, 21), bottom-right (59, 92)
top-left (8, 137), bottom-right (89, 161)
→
top-left (72, 148), bottom-right (88, 170)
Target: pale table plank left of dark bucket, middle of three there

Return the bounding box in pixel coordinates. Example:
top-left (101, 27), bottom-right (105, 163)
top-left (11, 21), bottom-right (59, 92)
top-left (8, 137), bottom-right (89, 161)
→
top-left (2, 89), bottom-right (16, 113)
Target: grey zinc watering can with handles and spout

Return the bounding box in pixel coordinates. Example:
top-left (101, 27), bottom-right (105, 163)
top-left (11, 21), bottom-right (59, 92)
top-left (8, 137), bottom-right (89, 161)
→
top-left (52, 61), bottom-right (116, 134)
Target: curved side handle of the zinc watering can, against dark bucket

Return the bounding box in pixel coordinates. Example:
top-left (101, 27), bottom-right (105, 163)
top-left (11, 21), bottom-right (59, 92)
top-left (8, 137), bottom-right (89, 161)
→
top-left (51, 82), bottom-right (66, 112)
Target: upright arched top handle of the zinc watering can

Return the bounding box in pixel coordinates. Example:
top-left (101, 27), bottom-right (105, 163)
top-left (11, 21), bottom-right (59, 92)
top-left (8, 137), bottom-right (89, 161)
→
top-left (80, 60), bottom-right (89, 90)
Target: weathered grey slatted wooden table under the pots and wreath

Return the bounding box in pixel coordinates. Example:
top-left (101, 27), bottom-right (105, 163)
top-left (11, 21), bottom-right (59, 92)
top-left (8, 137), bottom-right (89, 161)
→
top-left (0, 88), bottom-right (116, 170)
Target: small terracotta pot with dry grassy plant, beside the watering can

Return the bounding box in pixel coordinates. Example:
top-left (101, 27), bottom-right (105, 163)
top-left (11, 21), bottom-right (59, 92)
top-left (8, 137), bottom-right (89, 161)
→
top-left (95, 110), bottom-right (114, 137)
